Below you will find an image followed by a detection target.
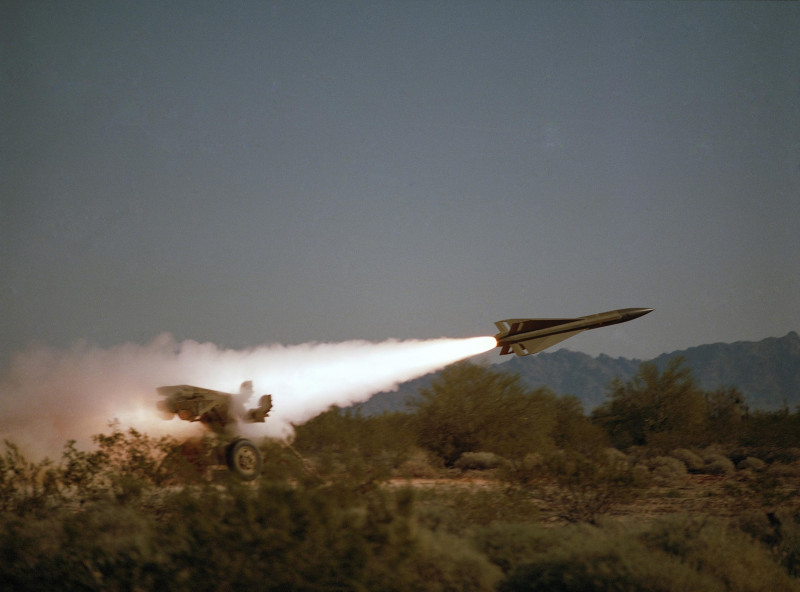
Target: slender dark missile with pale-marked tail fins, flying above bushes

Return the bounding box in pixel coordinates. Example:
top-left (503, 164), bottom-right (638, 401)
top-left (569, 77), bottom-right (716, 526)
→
top-left (494, 308), bottom-right (653, 356)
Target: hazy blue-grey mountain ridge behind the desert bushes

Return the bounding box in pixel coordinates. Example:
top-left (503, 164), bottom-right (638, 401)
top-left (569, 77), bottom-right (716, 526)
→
top-left (360, 331), bottom-right (800, 414)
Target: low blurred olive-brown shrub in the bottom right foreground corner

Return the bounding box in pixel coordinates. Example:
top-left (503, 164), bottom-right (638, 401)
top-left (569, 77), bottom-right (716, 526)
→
top-left (488, 517), bottom-right (798, 592)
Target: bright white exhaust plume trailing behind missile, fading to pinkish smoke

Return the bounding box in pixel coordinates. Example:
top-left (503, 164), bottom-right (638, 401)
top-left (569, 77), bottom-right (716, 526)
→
top-left (0, 334), bottom-right (496, 457)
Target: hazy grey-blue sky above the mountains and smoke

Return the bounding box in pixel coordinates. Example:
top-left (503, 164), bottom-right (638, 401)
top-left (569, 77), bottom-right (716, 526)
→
top-left (0, 0), bottom-right (800, 363)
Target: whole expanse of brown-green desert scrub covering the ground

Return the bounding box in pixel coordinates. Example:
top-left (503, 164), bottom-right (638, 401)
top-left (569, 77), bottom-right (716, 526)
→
top-left (0, 364), bottom-right (800, 591)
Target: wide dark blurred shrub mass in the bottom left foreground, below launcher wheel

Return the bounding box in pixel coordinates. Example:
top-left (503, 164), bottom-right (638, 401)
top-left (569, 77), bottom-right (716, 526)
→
top-left (0, 480), bottom-right (501, 591)
